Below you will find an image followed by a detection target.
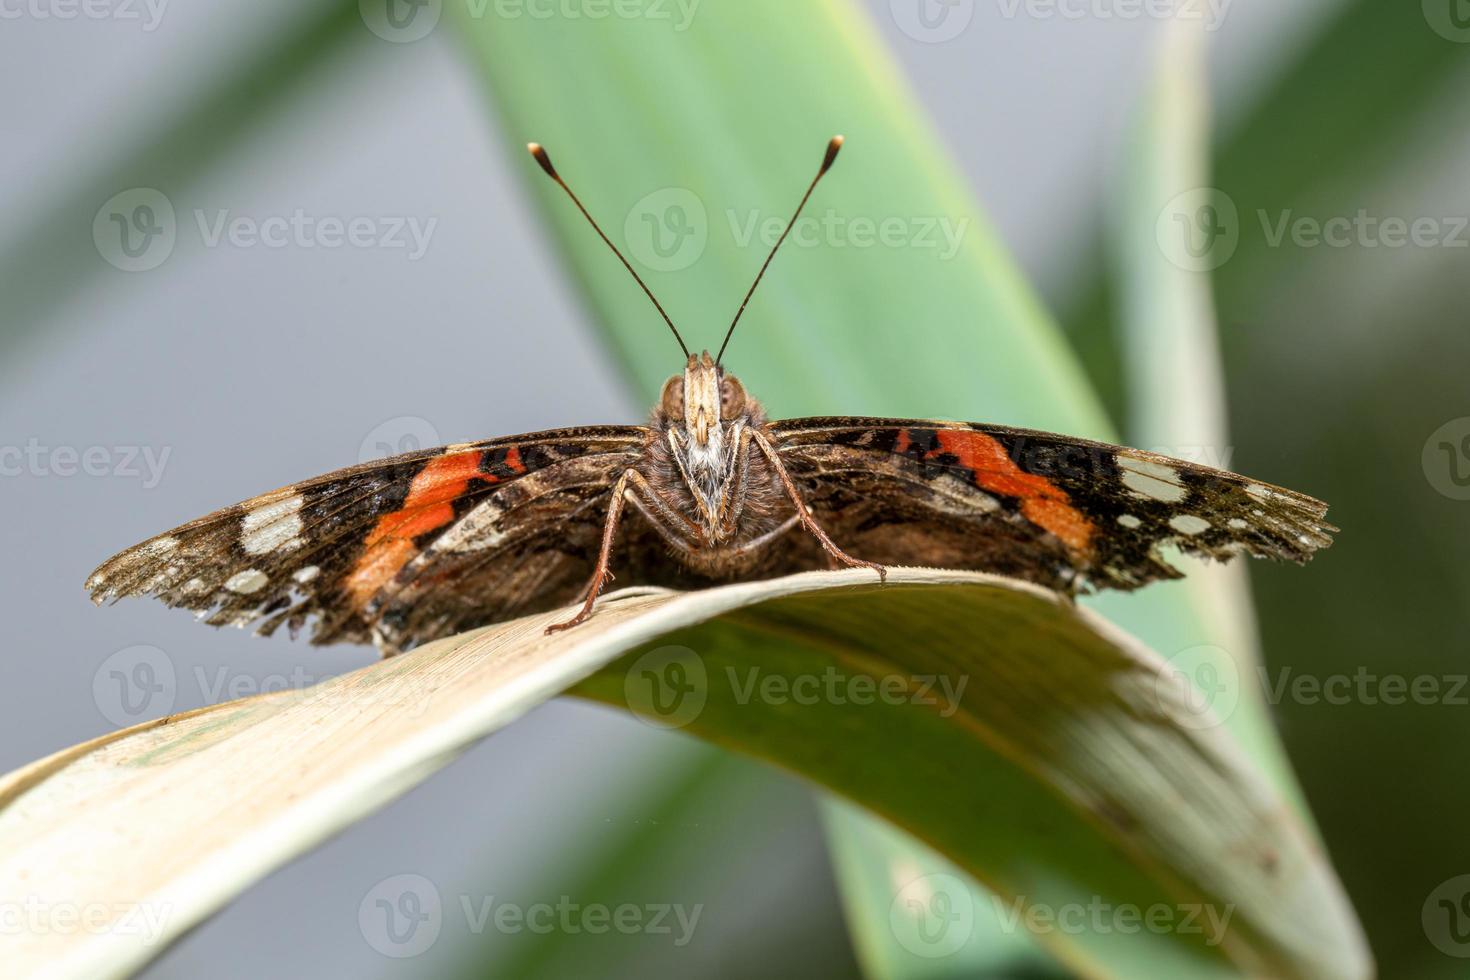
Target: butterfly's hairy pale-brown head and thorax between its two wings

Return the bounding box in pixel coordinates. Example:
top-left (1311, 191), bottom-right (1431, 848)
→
top-left (650, 353), bottom-right (779, 558)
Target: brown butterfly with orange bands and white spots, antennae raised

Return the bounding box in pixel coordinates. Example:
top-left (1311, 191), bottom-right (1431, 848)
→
top-left (87, 137), bottom-right (1336, 655)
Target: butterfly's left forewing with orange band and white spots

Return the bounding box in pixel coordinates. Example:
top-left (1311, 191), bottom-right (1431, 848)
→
top-left (87, 426), bottom-right (647, 646)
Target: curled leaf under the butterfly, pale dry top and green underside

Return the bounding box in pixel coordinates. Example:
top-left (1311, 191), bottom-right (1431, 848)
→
top-left (0, 569), bottom-right (1369, 977)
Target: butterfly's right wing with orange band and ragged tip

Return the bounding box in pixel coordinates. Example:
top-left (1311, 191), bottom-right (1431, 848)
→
top-left (773, 419), bottom-right (1336, 592)
